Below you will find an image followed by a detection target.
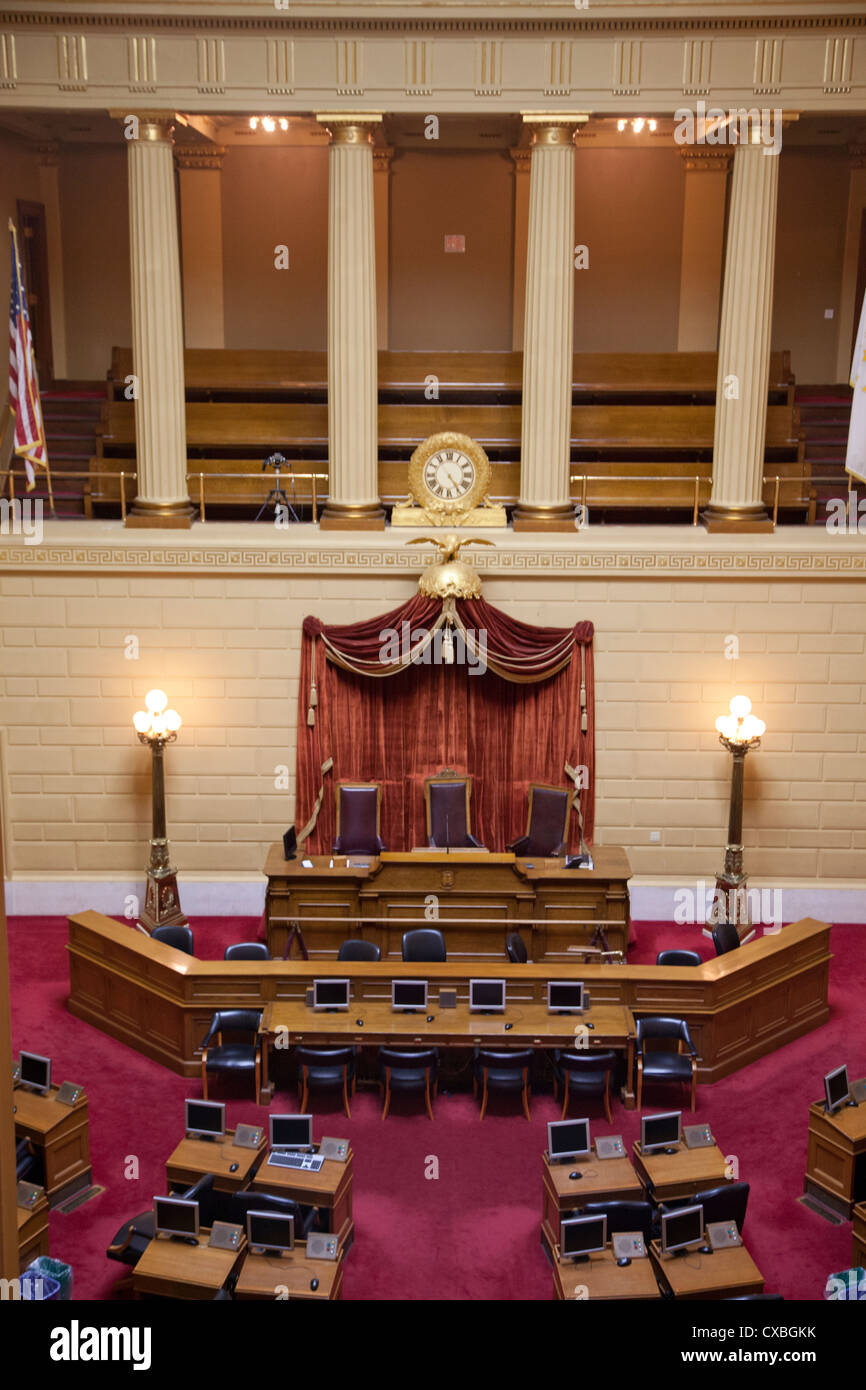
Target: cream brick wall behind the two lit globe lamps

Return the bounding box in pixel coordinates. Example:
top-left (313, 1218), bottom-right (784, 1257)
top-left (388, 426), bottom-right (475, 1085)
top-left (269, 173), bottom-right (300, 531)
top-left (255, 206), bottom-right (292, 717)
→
top-left (0, 527), bottom-right (866, 883)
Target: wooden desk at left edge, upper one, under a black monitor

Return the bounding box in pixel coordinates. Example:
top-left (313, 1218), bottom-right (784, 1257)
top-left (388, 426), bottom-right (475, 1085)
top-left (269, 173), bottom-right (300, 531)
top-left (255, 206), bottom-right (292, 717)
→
top-left (13, 1086), bottom-right (92, 1207)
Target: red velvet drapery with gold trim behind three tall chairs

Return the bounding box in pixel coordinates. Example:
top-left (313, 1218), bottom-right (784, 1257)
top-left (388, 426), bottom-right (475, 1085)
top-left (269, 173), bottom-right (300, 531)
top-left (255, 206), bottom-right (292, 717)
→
top-left (295, 595), bottom-right (595, 853)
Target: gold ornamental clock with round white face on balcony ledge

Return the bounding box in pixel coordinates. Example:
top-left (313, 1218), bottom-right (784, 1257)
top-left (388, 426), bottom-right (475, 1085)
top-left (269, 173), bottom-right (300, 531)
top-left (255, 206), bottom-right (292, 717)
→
top-left (391, 431), bottom-right (507, 527)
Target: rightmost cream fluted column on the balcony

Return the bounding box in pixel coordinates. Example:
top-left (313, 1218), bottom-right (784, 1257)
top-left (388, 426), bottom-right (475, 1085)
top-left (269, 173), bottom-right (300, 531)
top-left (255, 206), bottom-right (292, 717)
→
top-left (702, 143), bottom-right (778, 531)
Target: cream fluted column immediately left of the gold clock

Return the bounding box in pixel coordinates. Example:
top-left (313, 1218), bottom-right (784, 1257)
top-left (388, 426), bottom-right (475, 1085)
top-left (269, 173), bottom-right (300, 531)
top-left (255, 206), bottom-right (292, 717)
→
top-left (317, 113), bottom-right (385, 531)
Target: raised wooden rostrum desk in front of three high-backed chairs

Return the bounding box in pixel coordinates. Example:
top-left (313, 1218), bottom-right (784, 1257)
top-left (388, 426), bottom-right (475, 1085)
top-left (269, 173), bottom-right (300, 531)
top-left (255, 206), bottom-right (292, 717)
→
top-left (264, 844), bottom-right (631, 962)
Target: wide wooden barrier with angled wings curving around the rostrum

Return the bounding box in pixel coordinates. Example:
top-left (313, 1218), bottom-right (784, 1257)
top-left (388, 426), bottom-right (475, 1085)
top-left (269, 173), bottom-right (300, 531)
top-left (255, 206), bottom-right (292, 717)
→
top-left (67, 912), bottom-right (831, 1087)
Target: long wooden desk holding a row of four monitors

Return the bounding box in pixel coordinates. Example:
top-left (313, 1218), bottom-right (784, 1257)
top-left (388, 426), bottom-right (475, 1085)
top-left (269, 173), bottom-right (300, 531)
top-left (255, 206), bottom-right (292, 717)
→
top-left (261, 1000), bottom-right (635, 1105)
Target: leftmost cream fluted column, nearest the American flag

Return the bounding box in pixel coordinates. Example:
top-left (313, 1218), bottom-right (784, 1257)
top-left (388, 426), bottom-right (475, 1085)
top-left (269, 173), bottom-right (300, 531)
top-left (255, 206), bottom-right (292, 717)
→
top-left (125, 113), bottom-right (193, 527)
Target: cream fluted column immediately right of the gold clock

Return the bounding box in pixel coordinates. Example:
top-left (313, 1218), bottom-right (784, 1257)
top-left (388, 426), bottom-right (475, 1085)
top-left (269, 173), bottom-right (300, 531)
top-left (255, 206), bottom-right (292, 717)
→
top-left (513, 113), bottom-right (587, 531)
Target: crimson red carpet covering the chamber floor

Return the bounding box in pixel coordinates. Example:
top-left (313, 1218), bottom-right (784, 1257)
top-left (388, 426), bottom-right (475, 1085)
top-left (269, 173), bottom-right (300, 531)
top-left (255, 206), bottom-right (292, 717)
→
top-left (10, 917), bottom-right (866, 1300)
